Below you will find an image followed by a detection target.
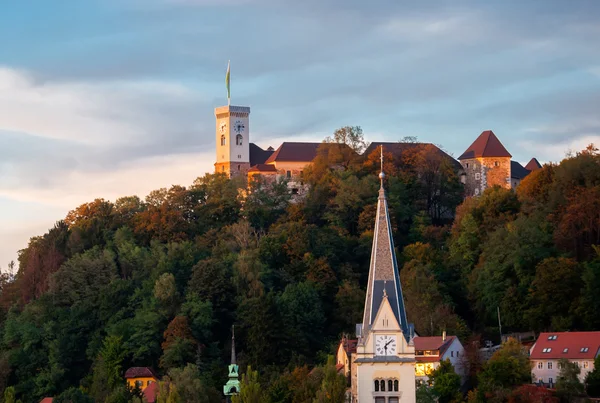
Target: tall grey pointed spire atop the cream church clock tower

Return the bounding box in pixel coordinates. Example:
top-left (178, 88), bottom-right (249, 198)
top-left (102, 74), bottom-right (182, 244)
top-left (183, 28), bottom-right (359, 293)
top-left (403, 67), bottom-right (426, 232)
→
top-left (362, 146), bottom-right (410, 340)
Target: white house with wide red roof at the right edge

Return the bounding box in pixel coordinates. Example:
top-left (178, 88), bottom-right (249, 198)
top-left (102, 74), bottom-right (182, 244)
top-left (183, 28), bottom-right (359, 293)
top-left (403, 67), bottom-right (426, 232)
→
top-left (529, 332), bottom-right (600, 385)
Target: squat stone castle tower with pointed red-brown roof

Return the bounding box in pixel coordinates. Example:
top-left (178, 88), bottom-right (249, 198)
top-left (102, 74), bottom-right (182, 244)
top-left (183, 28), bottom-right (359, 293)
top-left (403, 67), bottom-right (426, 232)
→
top-left (458, 130), bottom-right (512, 196)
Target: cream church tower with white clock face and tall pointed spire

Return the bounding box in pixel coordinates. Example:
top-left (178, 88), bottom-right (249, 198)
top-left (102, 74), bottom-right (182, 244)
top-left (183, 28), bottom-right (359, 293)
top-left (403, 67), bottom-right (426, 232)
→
top-left (352, 150), bottom-right (416, 403)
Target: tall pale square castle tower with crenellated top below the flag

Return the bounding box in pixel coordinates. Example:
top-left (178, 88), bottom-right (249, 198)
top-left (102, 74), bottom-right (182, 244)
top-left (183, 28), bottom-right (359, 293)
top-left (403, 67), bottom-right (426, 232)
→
top-left (215, 105), bottom-right (250, 177)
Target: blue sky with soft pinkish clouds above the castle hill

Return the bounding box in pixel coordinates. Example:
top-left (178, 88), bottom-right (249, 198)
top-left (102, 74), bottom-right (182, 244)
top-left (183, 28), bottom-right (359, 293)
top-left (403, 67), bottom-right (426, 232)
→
top-left (0, 0), bottom-right (600, 270)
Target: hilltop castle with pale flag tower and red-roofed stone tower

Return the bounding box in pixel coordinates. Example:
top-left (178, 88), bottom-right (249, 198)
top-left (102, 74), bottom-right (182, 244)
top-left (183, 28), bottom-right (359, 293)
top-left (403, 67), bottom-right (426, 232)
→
top-left (215, 105), bottom-right (541, 196)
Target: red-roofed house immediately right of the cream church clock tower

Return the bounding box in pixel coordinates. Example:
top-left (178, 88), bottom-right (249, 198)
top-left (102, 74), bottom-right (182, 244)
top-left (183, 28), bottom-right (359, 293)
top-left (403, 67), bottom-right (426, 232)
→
top-left (414, 332), bottom-right (466, 383)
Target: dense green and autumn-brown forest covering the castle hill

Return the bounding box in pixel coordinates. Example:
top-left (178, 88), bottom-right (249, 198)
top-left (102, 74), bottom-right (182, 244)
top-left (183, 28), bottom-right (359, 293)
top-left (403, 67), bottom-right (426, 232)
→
top-left (0, 129), bottom-right (600, 403)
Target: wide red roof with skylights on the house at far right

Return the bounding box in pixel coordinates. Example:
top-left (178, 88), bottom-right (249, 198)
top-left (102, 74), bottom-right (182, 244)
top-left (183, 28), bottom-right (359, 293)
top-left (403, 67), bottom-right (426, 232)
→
top-left (530, 332), bottom-right (600, 360)
